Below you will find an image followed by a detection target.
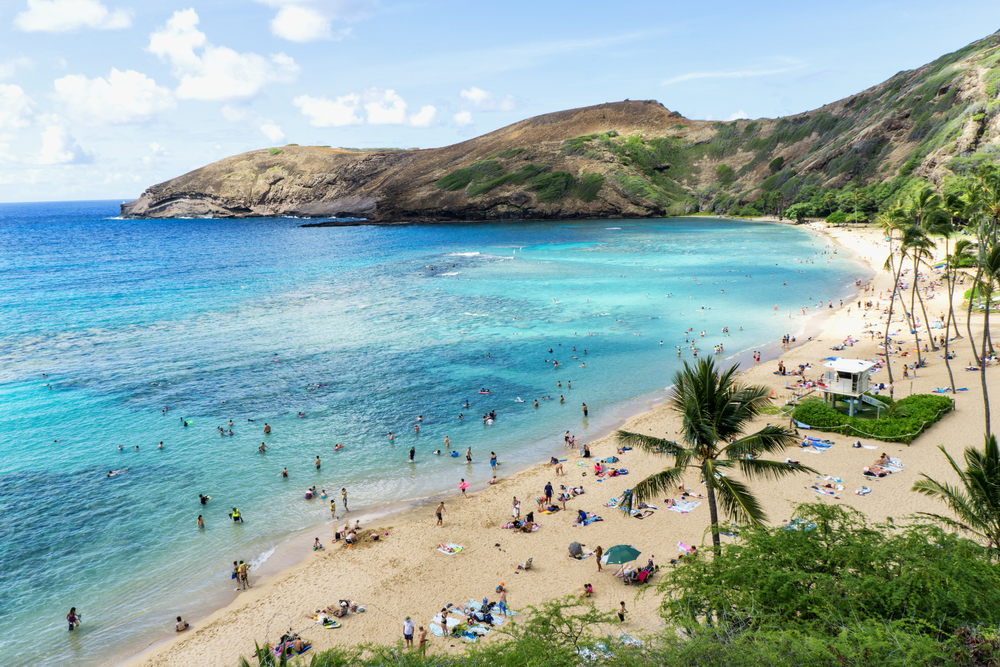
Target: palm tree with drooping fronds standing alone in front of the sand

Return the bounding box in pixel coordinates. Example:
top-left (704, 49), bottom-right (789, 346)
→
top-left (616, 358), bottom-right (816, 553)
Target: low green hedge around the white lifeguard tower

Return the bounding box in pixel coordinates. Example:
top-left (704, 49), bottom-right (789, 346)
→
top-left (792, 394), bottom-right (954, 444)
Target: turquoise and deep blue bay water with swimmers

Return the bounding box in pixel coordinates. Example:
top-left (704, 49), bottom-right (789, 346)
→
top-left (0, 202), bottom-right (864, 665)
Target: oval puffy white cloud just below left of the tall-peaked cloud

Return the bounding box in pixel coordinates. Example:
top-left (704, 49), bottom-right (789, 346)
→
top-left (54, 68), bottom-right (177, 125)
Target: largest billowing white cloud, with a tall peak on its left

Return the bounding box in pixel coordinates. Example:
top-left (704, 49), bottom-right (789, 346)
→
top-left (149, 9), bottom-right (299, 101)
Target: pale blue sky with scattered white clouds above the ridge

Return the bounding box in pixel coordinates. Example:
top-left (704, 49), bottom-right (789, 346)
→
top-left (0, 0), bottom-right (1000, 202)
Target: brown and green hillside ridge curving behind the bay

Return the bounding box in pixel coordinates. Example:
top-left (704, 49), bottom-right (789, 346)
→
top-left (122, 33), bottom-right (1000, 223)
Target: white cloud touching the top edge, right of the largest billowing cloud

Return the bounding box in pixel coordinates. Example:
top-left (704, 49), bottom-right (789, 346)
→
top-left (257, 0), bottom-right (378, 42)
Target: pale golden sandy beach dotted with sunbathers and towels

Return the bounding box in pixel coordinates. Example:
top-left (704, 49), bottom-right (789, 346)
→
top-left (128, 223), bottom-right (998, 667)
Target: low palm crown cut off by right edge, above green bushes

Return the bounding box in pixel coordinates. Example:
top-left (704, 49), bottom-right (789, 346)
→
top-left (913, 435), bottom-right (1000, 556)
